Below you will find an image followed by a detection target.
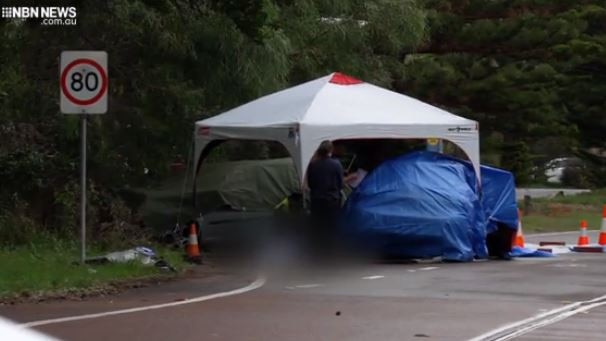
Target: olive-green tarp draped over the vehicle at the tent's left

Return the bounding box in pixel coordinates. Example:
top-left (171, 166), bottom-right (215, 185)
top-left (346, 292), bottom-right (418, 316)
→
top-left (196, 158), bottom-right (300, 212)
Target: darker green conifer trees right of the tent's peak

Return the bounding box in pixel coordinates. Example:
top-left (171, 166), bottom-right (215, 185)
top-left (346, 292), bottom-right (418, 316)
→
top-left (398, 0), bottom-right (606, 185)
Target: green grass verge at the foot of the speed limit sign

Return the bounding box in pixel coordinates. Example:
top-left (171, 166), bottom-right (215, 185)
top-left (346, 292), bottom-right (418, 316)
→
top-left (0, 238), bottom-right (187, 300)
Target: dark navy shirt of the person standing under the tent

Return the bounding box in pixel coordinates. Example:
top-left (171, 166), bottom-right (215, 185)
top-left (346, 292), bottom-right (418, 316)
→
top-left (307, 158), bottom-right (343, 201)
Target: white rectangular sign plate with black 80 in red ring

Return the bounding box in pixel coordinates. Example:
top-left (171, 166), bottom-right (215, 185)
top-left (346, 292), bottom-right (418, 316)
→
top-left (59, 51), bottom-right (109, 114)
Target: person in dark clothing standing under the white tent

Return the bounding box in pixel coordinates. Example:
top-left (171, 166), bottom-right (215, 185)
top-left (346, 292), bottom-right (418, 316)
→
top-left (307, 141), bottom-right (343, 251)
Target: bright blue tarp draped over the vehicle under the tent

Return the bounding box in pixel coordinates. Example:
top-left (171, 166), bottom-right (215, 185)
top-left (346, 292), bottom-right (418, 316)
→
top-left (343, 151), bottom-right (517, 261)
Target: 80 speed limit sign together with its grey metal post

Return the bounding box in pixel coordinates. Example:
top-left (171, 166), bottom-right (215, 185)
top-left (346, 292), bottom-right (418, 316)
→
top-left (59, 51), bottom-right (109, 264)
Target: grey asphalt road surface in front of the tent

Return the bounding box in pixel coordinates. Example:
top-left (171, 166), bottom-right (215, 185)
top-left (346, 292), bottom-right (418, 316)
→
top-left (0, 233), bottom-right (606, 341)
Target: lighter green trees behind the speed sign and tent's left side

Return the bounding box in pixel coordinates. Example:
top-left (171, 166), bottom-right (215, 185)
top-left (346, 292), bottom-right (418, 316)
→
top-left (0, 0), bottom-right (426, 240)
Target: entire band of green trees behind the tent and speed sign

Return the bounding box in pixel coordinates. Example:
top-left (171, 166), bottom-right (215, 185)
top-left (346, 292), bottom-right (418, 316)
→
top-left (0, 0), bottom-right (606, 240)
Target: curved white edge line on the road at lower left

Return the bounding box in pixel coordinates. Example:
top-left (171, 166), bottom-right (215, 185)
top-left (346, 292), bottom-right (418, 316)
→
top-left (20, 276), bottom-right (266, 327)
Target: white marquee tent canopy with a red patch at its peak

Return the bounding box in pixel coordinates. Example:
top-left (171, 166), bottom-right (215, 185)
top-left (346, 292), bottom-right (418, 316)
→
top-left (194, 73), bottom-right (480, 183)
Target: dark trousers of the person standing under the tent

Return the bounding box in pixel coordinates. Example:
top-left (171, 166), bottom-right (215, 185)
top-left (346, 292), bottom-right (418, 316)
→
top-left (310, 199), bottom-right (341, 255)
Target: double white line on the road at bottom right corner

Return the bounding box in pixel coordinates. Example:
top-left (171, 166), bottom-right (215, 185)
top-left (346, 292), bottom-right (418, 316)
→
top-left (468, 295), bottom-right (606, 341)
